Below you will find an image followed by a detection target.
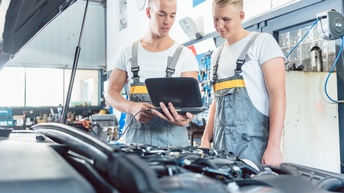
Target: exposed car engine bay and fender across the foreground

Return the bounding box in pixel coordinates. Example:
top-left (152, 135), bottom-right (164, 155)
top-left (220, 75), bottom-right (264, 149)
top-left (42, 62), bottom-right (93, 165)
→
top-left (0, 123), bottom-right (344, 193)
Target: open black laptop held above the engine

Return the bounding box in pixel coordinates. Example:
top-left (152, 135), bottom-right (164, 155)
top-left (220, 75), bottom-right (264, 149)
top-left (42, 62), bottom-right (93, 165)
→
top-left (145, 77), bottom-right (207, 115)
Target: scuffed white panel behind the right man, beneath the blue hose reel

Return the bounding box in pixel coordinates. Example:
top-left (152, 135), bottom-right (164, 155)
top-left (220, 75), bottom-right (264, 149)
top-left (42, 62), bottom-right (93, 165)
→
top-left (283, 71), bottom-right (340, 172)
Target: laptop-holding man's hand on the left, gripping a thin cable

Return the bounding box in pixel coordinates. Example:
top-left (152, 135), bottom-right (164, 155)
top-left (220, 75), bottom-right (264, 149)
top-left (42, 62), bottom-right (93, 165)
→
top-left (130, 102), bottom-right (154, 124)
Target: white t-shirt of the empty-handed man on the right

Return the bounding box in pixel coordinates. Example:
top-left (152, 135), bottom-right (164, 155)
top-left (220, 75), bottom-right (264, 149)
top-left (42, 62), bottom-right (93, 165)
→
top-left (210, 32), bottom-right (285, 116)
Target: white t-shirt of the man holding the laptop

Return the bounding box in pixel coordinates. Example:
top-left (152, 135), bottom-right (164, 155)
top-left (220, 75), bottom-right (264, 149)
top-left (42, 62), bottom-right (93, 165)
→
top-left (115, 42), bottom-right (199, 83)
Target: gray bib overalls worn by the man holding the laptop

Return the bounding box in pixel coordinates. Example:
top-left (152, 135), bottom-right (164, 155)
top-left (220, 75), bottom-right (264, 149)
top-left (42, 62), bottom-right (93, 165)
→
top-left (121, 41), bottom-right (189, 146)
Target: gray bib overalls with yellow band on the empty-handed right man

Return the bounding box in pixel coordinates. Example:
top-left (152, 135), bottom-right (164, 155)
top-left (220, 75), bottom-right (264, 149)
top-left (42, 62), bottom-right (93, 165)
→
top-left (213, 33), bottom-right (269, 163)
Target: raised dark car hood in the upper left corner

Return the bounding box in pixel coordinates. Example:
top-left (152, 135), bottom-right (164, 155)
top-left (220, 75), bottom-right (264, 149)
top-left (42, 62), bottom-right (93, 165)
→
top-left (0, 0), bottom-right (76, 70)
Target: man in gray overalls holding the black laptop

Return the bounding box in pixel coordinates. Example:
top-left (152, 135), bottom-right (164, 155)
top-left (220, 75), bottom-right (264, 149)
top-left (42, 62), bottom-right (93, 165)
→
top-left (105, 0), bottom-right (198, 146)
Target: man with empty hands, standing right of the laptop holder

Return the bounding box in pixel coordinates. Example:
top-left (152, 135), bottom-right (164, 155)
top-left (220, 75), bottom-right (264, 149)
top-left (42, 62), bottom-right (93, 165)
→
top-left (201, 0), bottom-right (286, 165)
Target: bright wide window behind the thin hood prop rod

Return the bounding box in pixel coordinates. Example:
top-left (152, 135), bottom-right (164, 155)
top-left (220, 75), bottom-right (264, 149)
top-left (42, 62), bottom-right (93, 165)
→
top-left (0, 67), bottom-right (99, 107)
